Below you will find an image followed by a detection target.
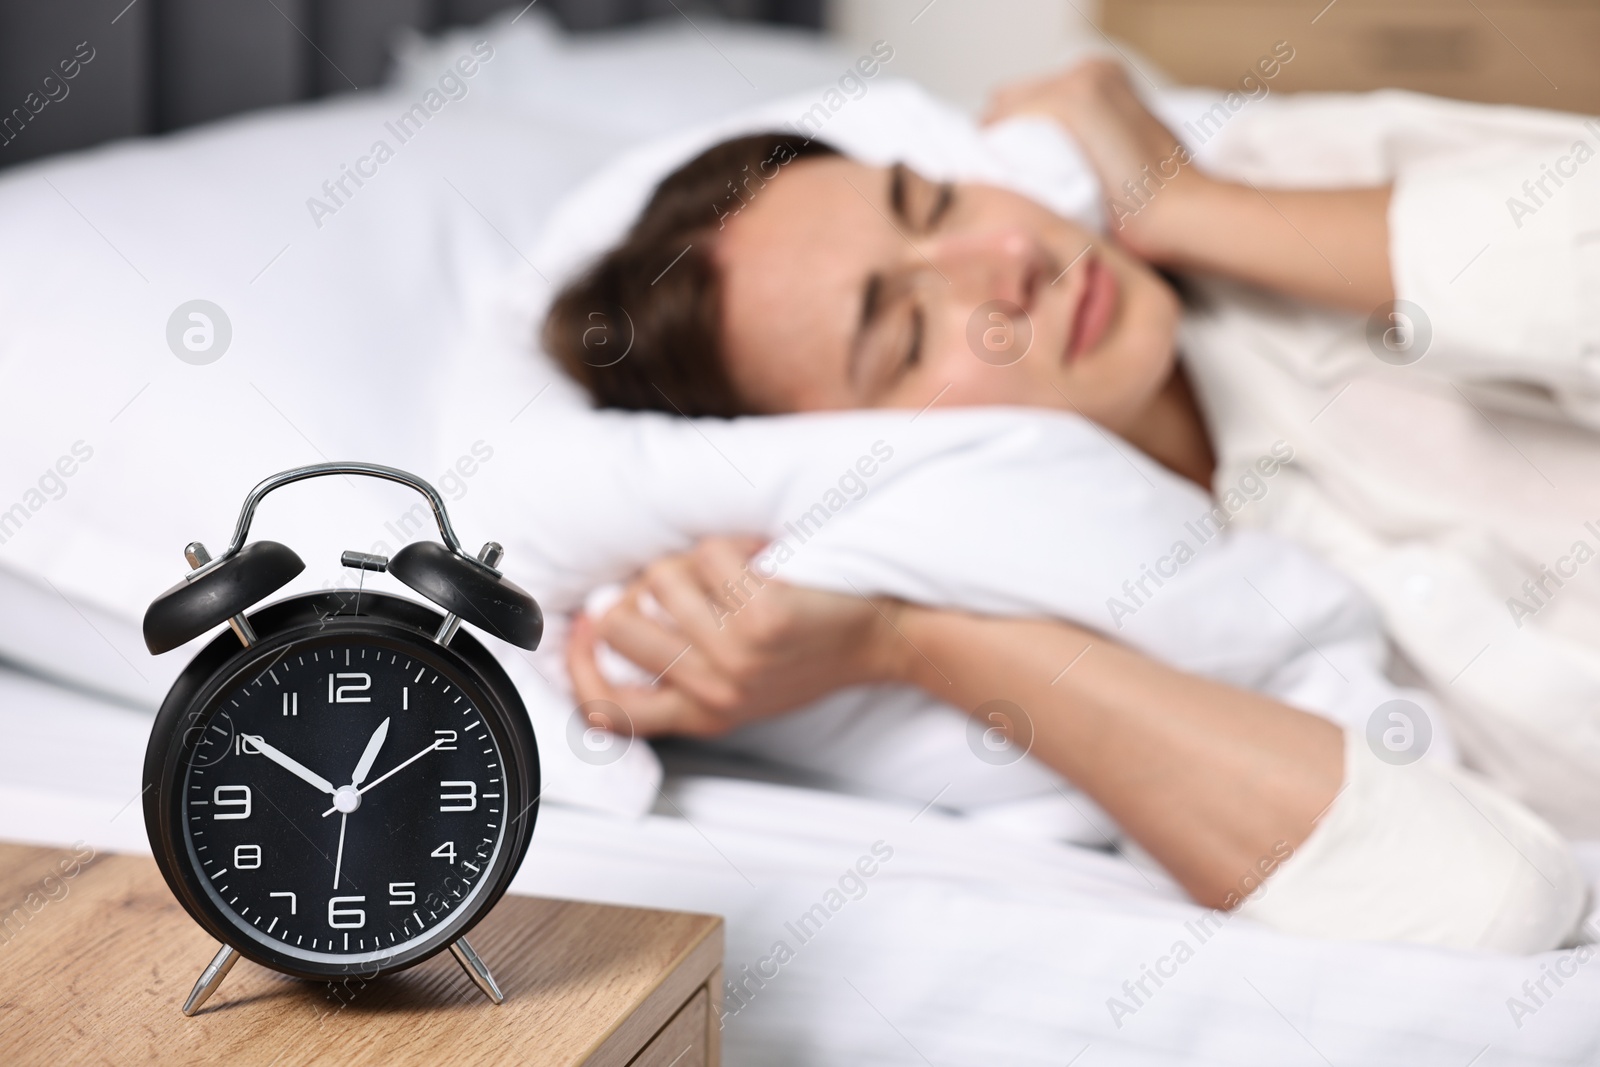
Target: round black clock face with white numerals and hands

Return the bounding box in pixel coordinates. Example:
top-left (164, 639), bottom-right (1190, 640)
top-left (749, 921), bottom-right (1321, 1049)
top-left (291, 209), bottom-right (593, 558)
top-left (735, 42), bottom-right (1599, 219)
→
top-left (179, 635), bottom-right (520, 966)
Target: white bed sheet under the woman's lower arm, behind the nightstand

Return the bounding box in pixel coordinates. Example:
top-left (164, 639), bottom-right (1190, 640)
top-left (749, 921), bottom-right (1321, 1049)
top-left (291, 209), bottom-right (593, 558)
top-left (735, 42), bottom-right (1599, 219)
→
top-left (0, 669), bottom-right (1600, 1067)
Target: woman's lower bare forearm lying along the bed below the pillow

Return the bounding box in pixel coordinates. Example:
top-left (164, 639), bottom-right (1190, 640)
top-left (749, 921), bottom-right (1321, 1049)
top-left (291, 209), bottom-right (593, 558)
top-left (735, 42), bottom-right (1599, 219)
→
top-left (898, 606), bottom-right (1344, 907)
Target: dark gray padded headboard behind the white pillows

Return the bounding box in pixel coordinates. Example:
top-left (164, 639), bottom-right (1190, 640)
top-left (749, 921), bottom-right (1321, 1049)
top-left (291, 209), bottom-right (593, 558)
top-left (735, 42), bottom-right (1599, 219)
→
top-left (0, 0), bottom-right (822, 166)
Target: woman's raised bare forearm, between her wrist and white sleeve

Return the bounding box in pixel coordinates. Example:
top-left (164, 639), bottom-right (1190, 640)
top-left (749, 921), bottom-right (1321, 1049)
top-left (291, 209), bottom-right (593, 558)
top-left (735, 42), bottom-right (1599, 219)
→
top-left (1150, 174), bottom-right (1395, 314)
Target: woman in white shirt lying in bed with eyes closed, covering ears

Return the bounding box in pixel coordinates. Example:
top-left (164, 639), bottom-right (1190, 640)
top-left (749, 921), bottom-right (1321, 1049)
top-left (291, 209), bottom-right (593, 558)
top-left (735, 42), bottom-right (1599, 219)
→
top-left (546, 61), bottom-right (1600, 952)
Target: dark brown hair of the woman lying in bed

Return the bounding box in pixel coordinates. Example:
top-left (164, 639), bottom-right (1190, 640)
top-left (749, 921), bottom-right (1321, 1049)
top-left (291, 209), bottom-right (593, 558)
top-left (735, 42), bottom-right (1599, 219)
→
top-left (542, 133), bottom-right (838, 418)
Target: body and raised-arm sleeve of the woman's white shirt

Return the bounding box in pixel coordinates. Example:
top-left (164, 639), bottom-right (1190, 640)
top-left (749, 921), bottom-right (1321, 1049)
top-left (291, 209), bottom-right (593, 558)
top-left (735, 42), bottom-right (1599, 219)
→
top-left (1181, 93), bottom-right (1600, 837)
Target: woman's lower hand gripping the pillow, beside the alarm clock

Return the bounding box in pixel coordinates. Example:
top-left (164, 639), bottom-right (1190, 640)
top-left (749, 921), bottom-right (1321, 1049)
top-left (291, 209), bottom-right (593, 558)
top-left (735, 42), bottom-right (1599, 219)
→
top-left (566, 537), bottom-right (906, 736)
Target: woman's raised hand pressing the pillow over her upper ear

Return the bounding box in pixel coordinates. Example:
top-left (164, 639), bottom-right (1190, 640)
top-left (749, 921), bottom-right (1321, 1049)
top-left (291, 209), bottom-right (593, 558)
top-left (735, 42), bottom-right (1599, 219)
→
top-left (984, 59), bottom-right (1208, 262)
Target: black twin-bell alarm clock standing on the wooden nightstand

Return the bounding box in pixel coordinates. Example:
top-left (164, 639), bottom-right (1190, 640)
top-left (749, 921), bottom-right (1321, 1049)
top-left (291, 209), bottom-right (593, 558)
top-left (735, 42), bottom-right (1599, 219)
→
top-left (144, 462), bottom-right (544, 1016)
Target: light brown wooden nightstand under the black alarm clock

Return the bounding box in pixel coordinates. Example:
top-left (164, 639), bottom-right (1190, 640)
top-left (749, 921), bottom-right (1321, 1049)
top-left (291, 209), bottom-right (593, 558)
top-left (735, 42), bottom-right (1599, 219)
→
top-left (0, 845), bottom-right (723, 1067)
